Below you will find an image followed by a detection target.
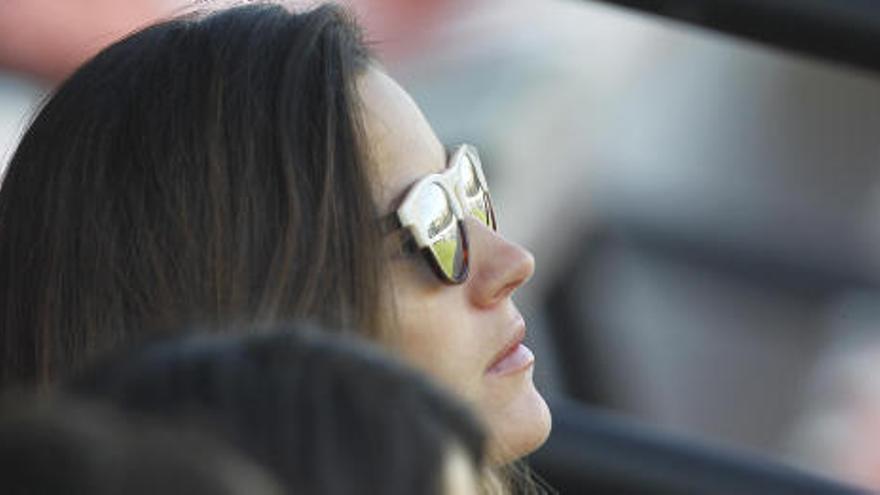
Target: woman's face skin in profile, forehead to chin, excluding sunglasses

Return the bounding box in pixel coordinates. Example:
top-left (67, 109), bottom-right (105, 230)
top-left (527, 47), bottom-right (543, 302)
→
top-left (359, 68), bottom-right (550, 463)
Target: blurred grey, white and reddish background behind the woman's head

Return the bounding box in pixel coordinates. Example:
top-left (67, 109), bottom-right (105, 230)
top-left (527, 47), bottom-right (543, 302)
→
top-left (0, 0), bottom-right (880, 490)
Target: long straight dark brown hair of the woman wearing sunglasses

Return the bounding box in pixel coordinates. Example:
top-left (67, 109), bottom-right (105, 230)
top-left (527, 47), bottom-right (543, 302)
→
top-left (0, 1), bottom-right (383, 386)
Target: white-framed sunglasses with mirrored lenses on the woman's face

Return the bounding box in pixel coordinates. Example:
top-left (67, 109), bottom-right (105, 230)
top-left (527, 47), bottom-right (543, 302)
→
top-left (383, 144), bottom-right (498, 284)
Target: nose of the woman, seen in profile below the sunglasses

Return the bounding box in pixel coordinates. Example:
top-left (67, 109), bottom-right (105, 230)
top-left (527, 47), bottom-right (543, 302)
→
top-left (465, 218), bottom-right (535, 307)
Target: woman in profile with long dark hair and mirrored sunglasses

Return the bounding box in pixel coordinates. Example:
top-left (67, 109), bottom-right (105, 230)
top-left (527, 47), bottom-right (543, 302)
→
top-left (0, 1), bottom-right (550, 463)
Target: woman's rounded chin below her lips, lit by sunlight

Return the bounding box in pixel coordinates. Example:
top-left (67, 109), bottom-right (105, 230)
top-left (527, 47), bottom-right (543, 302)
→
top-left (485, 380), bottom-right (552, 465)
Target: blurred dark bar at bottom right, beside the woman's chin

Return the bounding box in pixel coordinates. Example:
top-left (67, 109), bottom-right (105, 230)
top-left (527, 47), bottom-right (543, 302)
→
top-left (529, 402), bottom-right (867, 495)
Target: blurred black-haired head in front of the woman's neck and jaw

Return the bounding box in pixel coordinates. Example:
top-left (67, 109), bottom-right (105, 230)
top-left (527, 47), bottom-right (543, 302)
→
top-left (68, 325), bottom-right (485, 495)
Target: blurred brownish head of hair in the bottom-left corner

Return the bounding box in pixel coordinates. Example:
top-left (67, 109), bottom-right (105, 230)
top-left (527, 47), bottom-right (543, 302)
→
top-left (0, 397), bottom-right (285, 495)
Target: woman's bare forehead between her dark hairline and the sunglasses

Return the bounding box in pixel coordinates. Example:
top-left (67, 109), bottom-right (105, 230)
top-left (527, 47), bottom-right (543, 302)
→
top-left (358, 68), bottom-right (446, 211)
